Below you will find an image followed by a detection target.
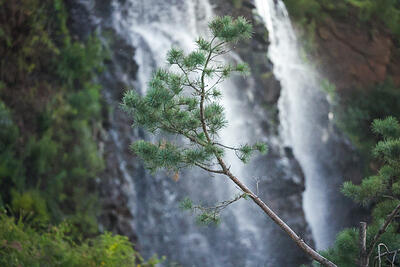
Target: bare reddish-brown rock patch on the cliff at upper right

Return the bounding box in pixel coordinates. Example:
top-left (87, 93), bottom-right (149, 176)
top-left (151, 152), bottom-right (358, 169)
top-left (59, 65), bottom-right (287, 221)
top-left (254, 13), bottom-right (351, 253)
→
top-left (308, 14), bottom-right (400, 94)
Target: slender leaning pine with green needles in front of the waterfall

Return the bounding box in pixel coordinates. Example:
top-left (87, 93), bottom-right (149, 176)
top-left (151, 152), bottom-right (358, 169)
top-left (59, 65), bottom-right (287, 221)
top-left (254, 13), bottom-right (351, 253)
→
top-left (122, 16), bottom-right (336, 266)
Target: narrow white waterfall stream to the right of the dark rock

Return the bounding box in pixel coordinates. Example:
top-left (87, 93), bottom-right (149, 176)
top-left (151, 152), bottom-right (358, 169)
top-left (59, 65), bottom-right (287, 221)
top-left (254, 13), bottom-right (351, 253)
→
top-left (255, 0), bottom-right (358, 249)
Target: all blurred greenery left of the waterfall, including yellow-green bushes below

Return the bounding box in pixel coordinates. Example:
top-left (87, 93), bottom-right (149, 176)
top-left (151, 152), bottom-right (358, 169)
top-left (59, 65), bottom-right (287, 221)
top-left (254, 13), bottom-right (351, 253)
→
top-left (0, 0), bottom-right (157, 266)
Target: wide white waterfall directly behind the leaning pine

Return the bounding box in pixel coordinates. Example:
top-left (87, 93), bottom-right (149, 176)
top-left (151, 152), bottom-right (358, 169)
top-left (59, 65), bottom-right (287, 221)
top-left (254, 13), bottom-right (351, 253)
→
top-left (77, 0), bottom-right (324, 266)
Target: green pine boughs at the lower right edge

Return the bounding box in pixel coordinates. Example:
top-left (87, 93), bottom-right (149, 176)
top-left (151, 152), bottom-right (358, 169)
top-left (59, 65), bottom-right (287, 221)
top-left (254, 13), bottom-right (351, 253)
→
top-left (318, 117), bottom-right (400, 267)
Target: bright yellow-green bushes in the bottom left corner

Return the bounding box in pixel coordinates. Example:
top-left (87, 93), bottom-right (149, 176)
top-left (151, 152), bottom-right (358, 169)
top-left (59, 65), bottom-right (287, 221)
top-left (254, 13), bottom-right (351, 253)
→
top-left (0, 213), bottom-right (160, 267)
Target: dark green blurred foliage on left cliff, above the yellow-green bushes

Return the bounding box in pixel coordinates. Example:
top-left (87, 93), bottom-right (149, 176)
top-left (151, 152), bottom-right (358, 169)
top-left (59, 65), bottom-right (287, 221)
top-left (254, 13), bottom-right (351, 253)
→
top-left (0, 0), bottom-right (103, 237)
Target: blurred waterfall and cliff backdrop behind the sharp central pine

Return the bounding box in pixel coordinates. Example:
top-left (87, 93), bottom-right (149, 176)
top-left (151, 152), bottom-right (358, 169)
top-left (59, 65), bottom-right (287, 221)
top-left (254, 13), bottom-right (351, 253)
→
top-left (0, 0), bottom-right (400, 266)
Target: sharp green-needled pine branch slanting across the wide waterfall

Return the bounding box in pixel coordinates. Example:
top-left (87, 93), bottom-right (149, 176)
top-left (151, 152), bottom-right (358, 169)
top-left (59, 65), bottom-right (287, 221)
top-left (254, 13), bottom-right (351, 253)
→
top-left (124, 17), bottom-right (336, 267)
